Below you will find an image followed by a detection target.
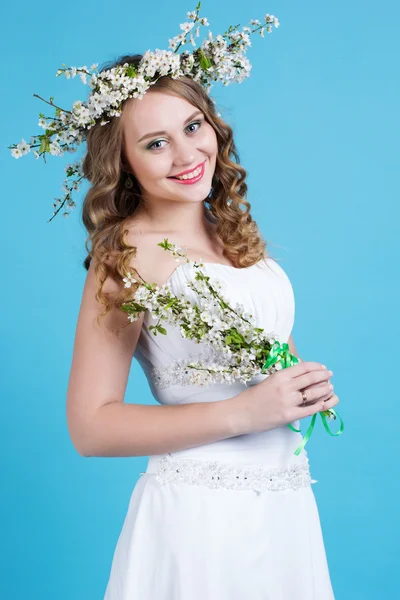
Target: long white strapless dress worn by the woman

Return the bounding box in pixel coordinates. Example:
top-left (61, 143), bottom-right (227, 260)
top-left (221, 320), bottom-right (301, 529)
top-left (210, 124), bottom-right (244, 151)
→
top-left (104, 258), bottom-right (334, 600)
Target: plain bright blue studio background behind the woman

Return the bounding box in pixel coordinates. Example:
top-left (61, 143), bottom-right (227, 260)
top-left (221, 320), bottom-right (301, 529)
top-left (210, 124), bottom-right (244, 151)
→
top-left (0, 0), bottom-right (400, 600)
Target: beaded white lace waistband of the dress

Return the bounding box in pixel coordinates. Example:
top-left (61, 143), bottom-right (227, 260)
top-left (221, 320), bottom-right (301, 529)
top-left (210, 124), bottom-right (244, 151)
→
top-left (147, 454), bottom-right (317, 491)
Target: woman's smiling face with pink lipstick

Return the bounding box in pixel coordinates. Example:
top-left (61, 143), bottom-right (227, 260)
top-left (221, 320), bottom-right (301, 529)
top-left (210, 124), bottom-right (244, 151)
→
top-left (120, 91), bottom-right (218, 202)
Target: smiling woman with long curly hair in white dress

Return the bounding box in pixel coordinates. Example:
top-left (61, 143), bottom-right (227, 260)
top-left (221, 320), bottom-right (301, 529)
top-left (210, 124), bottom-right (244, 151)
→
top-left (67, 55), bottom-right (339, 600)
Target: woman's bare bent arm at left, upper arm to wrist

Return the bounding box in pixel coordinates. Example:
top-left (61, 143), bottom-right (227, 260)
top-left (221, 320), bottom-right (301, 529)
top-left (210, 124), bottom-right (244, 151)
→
top-left (67, 255), bottom-right (249, 456)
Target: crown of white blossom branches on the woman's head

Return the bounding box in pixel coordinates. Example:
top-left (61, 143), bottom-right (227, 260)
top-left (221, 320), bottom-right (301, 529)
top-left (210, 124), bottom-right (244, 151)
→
top-left (8, 2), bottom-right (279, 222)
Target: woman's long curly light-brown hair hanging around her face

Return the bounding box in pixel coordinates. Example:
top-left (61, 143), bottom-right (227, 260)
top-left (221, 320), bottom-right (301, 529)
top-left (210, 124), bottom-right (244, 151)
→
top-left (82, 54), bottom-right (268, 324)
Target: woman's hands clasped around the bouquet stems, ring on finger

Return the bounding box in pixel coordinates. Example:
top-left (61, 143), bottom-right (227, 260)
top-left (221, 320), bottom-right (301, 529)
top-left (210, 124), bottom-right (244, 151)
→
top-left (239, 362), bottom-right (339, 433)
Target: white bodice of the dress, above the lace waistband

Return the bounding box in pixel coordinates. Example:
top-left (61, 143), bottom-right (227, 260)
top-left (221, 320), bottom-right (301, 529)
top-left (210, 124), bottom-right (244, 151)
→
top-left (134, 257), bottom-right (307, 466)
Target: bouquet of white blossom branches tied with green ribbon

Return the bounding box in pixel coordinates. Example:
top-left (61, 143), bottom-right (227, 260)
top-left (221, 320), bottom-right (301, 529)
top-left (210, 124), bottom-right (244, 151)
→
top-left (121, 238), bottom-right (343, 454)
